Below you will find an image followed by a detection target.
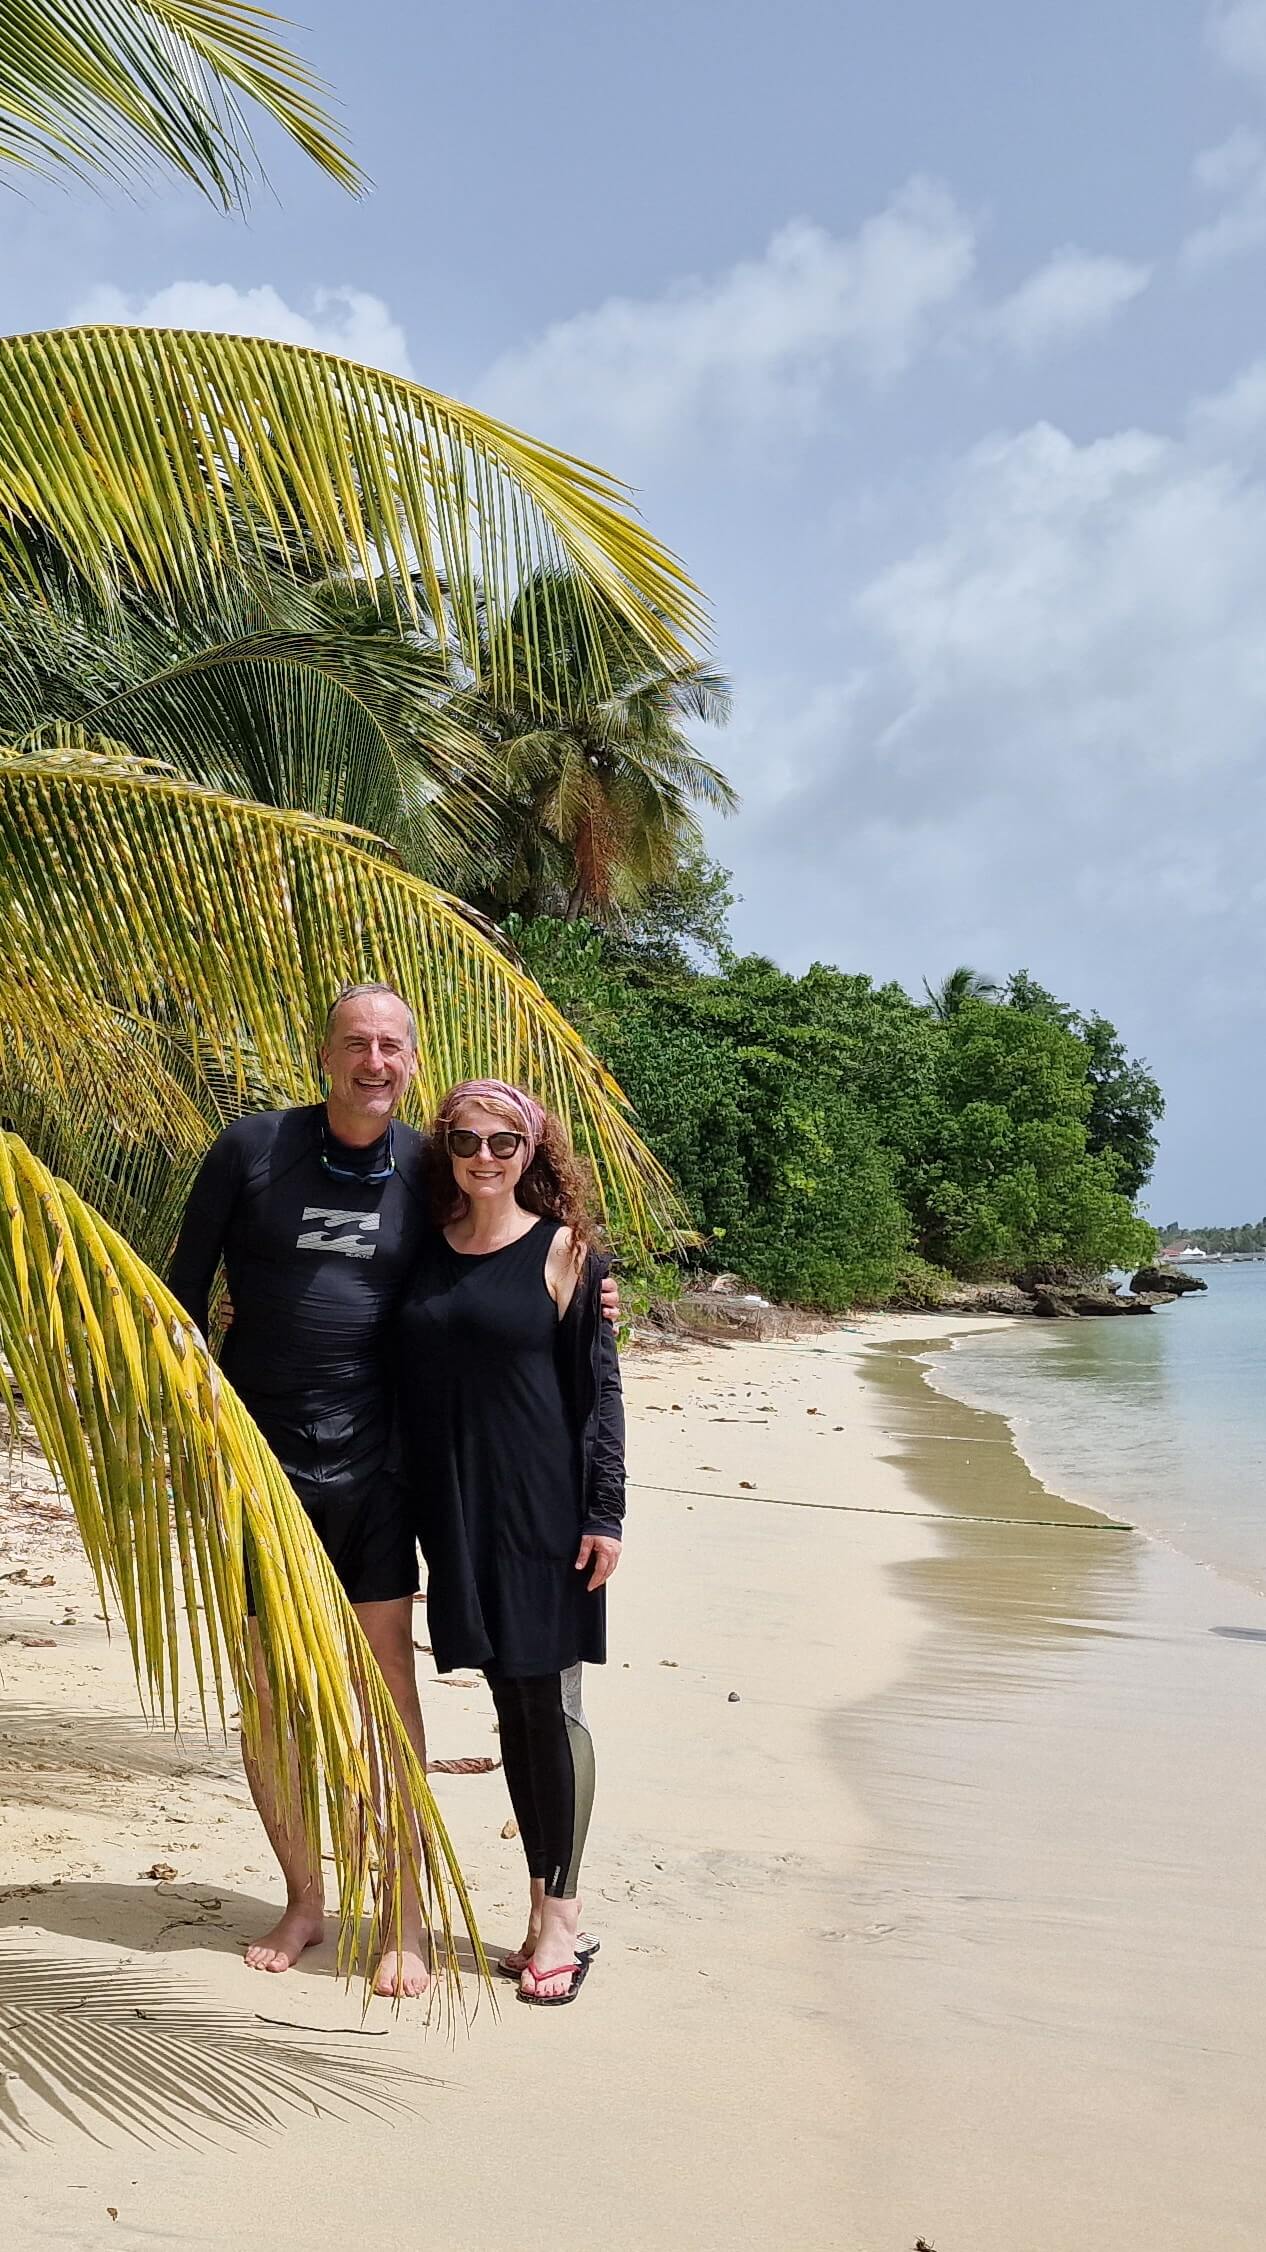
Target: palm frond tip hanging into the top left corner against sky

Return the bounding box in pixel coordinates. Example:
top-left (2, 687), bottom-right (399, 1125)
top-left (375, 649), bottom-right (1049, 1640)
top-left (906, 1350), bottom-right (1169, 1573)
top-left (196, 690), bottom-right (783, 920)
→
top-left (0, 0), bottom-right (365, 209)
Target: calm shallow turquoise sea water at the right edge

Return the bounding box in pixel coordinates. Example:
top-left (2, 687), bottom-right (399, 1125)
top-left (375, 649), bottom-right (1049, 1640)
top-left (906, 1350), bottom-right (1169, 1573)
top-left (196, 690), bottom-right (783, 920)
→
top-left (933, 1263), bottom-right (1266, 1594)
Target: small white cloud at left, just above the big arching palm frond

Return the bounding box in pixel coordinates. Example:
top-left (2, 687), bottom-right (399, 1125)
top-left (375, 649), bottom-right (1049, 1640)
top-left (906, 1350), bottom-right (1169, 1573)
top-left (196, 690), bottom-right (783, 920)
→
top-left (70, 282), bottom-right (412, 376)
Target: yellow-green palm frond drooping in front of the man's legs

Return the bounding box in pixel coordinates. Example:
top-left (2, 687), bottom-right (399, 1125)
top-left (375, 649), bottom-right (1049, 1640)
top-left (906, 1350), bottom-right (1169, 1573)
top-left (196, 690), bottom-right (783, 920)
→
top-left (0, 1133), bottom-right (482, 1984)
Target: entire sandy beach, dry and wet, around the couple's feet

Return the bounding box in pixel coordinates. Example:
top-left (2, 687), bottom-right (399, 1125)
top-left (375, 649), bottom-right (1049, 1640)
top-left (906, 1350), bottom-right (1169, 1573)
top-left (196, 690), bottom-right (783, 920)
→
top-left (0, 1317), bottom-right (1266, 2252)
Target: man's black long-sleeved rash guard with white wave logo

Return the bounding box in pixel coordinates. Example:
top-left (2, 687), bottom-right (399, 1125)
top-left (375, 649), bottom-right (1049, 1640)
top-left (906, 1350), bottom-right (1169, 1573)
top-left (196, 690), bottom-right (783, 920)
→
top-left (169, 1103), bottom-right (430, 1423)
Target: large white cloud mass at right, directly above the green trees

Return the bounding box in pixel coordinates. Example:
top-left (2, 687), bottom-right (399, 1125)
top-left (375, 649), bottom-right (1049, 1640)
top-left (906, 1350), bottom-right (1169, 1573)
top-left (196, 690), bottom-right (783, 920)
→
top-left (719, 363), bottom-right (1266, 1070)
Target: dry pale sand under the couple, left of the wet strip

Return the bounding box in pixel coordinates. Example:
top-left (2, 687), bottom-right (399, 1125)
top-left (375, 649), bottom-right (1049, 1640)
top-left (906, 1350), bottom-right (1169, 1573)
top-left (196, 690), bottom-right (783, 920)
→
top-left (0, 1320), bottom-right (966, 2252)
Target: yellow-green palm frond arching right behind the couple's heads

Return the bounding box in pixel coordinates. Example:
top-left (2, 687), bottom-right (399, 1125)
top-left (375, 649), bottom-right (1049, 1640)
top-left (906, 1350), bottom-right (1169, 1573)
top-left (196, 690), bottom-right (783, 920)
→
top-left (0, 750), bottom-right (676, 1241)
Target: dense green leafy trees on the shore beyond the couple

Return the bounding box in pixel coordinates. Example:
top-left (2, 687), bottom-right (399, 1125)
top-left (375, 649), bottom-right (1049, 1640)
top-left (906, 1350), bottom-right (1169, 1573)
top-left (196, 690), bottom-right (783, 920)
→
top-left (514, 919), bottom-right (1160, 1311)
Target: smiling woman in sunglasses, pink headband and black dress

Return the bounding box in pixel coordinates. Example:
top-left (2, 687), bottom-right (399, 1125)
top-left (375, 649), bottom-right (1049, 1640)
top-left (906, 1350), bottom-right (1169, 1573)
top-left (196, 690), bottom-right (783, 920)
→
top-left (399, 1079), bottom-right (624, 2009)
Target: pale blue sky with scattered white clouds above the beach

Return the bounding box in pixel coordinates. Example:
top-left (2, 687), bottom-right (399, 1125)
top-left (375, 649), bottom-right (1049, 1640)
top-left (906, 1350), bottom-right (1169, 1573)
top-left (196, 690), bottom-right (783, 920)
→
top-left (9, 0), bottom-right (1266, 1223)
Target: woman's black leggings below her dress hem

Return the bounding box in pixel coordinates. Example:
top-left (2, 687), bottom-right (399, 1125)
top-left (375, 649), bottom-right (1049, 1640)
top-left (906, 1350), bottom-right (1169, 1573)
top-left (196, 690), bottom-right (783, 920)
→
top-left (484, 1666), bottom-right (592, 1901)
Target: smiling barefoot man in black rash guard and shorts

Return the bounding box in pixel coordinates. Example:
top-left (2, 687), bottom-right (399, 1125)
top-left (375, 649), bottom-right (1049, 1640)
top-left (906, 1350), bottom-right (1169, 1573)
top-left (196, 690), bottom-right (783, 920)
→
top-left (169, 984), bottom-right (615, 1995)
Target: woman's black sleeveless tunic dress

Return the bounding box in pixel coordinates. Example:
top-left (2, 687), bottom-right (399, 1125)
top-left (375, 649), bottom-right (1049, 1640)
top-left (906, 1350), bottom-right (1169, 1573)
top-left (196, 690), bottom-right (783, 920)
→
top-left (389, 1221), bottom-right (622, 1675)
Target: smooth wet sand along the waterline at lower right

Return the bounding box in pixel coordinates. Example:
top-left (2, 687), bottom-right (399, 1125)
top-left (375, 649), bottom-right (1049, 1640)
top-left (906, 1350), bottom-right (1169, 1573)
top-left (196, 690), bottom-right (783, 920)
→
top-left (831, 1344), bottom-right (1266, 2252)
